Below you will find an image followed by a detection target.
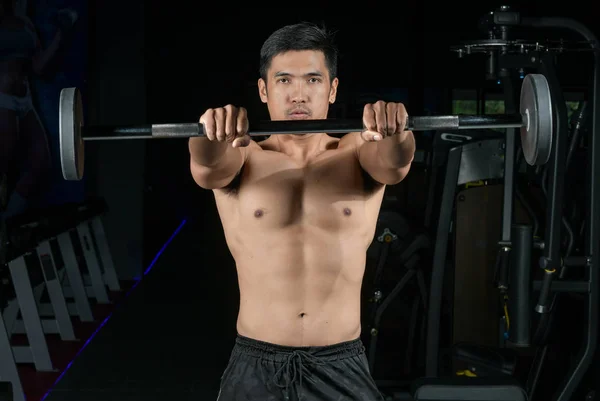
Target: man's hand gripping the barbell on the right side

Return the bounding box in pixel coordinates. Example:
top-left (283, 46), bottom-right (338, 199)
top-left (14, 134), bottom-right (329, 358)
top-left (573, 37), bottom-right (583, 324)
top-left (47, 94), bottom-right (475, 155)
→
top-left (361, 100), bottom-right (408, 142)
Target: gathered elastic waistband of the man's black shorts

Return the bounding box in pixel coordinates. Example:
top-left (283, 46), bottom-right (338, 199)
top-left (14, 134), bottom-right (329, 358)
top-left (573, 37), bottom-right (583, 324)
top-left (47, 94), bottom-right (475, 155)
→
top-left (234, 334), bottom-right (365, 362)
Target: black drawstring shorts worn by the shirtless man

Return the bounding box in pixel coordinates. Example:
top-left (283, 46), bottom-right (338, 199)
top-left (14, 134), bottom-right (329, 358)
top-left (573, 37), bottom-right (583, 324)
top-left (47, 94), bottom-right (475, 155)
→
top-left (217, 335), bottom-right (383, 401)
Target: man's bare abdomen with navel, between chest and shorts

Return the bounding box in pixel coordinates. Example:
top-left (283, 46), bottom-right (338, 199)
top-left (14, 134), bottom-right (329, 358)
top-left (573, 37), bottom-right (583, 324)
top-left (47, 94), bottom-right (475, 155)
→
top-left (228, 225), bottom-right (368, 346)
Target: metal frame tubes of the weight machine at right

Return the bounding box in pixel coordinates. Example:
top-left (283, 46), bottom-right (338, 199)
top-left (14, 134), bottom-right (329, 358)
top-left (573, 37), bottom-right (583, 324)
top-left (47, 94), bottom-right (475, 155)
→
top-left (425, 12), bottom-right (600, 401)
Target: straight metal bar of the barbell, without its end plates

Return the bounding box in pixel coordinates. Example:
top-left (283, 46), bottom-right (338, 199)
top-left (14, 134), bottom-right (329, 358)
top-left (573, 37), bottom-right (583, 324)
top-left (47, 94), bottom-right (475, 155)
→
top-left (81, 114), bottom-right (523, 141)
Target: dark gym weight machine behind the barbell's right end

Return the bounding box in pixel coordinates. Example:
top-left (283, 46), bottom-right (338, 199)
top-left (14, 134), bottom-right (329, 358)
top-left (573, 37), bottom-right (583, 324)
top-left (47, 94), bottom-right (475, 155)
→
top-left (412, 7), bottom-right (600, 401)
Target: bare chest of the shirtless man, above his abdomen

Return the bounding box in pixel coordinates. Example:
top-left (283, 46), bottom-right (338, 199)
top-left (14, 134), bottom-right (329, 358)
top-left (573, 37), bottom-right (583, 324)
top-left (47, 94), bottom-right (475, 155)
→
top-left (218, 147), bottom-right (379, 227)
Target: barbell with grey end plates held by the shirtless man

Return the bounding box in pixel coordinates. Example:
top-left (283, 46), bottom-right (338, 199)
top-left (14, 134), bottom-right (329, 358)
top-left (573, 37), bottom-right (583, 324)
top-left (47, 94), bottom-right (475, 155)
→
top-left (59, 74), bottom-right (553, 181)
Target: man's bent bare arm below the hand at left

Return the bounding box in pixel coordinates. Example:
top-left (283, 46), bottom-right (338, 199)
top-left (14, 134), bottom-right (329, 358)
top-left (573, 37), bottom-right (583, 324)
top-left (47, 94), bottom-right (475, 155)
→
top-left (188, 137), bottom-right (255, 189)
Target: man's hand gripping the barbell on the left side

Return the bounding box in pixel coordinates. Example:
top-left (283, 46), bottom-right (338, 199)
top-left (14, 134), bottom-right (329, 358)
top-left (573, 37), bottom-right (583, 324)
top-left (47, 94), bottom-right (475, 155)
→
top-left (200, 105), bottom-right (250, 148)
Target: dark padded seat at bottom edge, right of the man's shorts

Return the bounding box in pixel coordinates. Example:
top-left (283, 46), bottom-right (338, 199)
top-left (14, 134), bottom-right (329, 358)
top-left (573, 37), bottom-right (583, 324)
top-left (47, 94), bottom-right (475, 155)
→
top-left (411, 377), bottom-right (527, 401)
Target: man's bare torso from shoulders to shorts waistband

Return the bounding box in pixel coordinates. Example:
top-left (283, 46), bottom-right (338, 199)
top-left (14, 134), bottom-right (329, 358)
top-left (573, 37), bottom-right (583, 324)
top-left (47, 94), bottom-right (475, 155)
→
top-left (214, 134), bottom-right (385, 346)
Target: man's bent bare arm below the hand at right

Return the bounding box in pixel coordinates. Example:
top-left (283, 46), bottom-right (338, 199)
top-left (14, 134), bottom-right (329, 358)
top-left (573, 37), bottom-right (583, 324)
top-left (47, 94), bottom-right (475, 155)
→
top-left (355, 131), bottom-right (416, 185)
